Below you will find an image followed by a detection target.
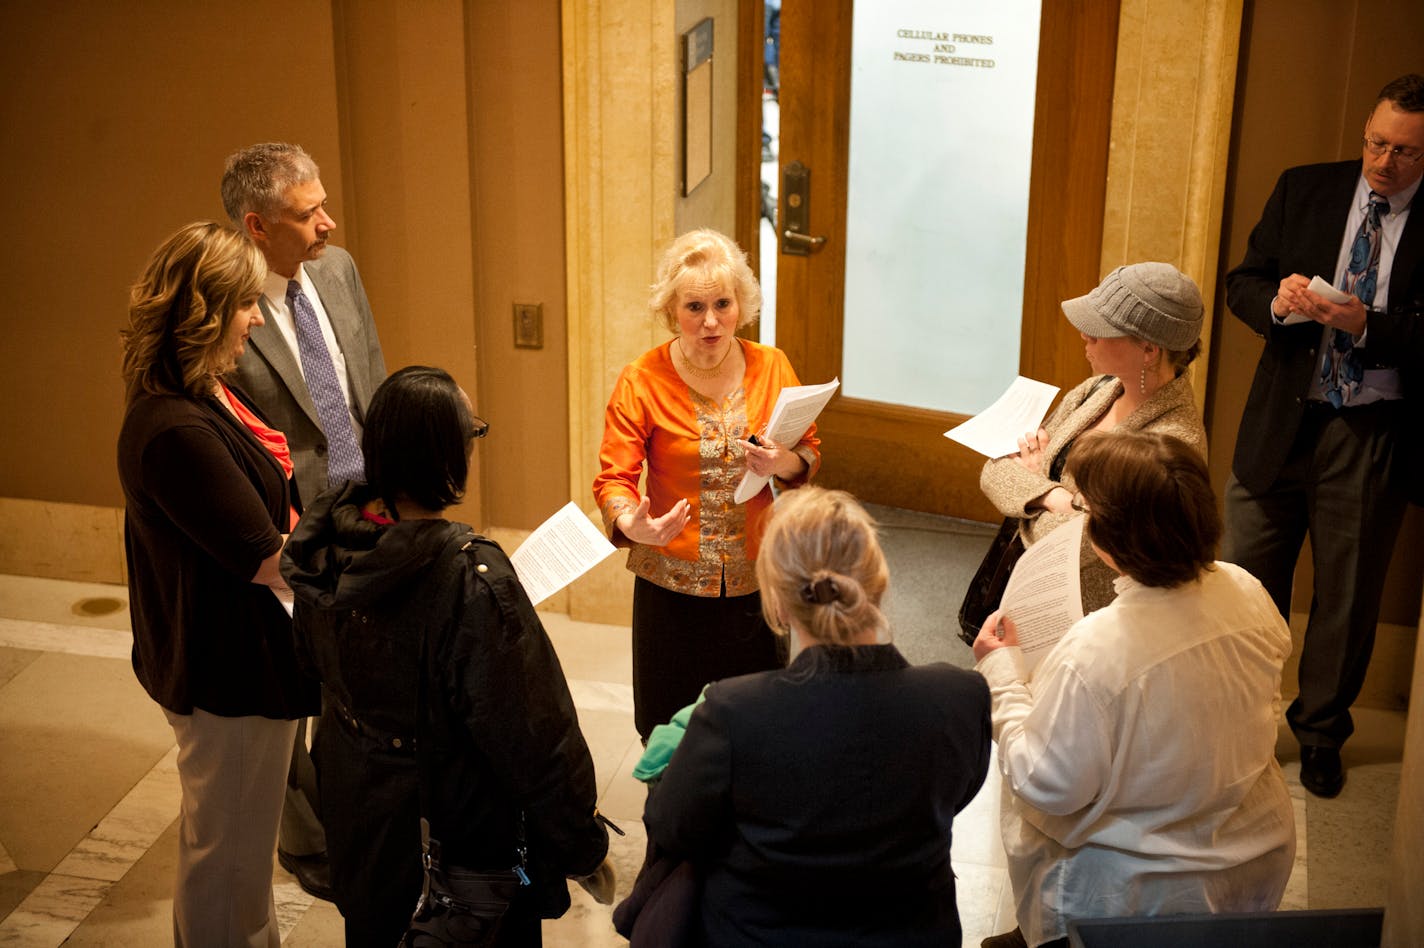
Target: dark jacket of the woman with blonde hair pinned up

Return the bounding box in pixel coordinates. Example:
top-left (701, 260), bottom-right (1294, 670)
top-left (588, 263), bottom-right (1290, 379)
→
top-left (644, 645), bottom-right (990, 947)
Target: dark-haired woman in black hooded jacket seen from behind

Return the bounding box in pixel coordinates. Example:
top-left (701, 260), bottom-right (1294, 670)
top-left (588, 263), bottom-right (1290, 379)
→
top-left (282, 366), bottom-right (608, 948)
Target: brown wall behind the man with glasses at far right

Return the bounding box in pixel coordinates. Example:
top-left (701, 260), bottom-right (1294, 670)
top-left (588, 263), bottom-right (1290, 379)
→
top-left (1206, 0), bottom-right (1424, 626)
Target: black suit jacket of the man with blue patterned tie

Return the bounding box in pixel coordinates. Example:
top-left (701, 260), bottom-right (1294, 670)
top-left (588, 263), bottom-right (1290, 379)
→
top-left (1226, 161), bottom-right (1424, 493)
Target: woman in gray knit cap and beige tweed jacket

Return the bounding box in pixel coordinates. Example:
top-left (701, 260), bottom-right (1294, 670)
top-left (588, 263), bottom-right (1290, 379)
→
top-left (980, 263), bottom-right (1206, 612)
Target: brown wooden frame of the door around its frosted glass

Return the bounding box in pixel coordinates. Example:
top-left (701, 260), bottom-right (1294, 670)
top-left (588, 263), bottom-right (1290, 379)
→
top-left (739, 0), bottom-right (1118, 521)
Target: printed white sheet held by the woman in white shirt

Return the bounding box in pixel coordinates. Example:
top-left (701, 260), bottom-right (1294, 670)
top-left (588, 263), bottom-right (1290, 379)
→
top-left (1000, 517), bottom-right (1085, 670)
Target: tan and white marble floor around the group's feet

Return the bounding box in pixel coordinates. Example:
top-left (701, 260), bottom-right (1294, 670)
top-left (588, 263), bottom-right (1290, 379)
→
top-left (0, 576), bottom-right (1404, 948)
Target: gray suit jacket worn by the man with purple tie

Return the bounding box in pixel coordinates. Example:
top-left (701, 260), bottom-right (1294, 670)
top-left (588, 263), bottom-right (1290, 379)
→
top-left (235, 246), bottom-right (386, 504)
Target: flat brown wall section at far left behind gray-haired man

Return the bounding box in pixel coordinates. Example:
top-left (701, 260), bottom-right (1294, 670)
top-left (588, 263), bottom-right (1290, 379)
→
top-left (0, 0), bottom-right (350, 507)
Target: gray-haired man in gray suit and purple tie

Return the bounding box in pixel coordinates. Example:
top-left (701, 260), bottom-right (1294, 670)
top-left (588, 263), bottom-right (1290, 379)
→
top-left (222, 142), bottom-right (386, 900)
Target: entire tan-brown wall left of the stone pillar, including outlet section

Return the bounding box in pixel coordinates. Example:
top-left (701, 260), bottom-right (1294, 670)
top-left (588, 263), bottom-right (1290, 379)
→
top-left (0, 0), bottom-right (568, 560)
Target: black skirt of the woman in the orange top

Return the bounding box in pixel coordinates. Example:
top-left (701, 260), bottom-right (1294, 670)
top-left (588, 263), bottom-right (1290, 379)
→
top-left (632, 576), bottom-right (785, 742)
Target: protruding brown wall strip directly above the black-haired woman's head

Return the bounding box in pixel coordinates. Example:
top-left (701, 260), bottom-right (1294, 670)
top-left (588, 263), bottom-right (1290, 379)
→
top-left (325, 0), bottom-right (486, 525)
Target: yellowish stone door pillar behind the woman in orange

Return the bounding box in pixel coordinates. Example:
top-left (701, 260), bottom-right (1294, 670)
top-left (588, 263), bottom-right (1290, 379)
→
top-left (562, 0), bottom-right (678, 622)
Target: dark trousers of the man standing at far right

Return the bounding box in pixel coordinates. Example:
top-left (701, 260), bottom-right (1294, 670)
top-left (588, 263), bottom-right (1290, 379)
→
top-left (1222, 401), bottom-right (1407, 747)
